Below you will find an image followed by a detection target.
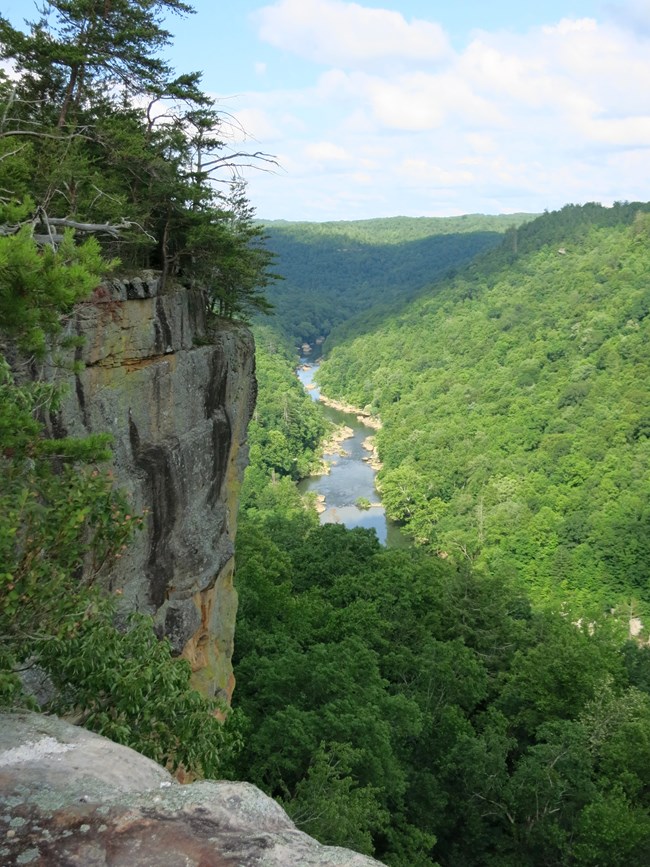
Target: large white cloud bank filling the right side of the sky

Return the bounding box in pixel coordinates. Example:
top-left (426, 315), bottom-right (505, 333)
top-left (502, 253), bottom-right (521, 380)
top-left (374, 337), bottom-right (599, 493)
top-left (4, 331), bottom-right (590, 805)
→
top-left (232, 0), bottom-right (650, 219)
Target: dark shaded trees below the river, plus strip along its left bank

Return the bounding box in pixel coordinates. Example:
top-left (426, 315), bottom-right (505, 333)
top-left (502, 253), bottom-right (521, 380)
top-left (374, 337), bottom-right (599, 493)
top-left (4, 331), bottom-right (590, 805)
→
top-left (233, 320), bottom-right (650, 867)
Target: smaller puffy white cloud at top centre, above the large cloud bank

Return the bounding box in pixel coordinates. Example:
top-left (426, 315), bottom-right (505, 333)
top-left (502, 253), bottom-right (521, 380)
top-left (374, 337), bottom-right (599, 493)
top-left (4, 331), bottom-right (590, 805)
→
top-left (253, 0), bottom-right (450, 67)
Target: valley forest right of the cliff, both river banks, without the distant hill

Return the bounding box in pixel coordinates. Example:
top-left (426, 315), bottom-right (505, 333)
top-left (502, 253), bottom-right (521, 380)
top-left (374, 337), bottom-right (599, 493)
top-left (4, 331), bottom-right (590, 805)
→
top-left (229, 203), bottom-right (650, 867)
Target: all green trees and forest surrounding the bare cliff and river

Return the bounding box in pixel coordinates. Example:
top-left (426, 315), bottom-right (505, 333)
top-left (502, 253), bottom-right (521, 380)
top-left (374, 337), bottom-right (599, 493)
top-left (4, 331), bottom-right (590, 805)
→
top-left (0, 0), bottom-right (650, 867)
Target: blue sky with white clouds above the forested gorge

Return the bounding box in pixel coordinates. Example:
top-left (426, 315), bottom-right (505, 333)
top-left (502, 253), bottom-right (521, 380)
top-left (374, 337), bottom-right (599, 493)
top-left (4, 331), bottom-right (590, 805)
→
top-left (3, 0), bottom-right (650, 221)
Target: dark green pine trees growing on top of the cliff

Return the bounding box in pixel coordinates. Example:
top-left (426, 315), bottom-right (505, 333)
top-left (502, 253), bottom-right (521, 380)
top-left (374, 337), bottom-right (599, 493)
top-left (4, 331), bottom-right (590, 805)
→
top-left (0, 0), bottom-right (275, 318)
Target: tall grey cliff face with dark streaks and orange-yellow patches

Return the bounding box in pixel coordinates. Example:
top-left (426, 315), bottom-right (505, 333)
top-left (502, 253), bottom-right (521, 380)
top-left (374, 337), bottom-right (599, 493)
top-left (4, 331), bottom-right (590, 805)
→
top-left (51, 275), bottom-right (256, 698)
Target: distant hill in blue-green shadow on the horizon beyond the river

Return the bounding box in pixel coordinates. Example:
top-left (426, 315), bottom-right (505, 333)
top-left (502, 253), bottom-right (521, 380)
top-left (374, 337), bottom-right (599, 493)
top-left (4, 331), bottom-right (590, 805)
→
top-left (263, 214), bottom-right (531, 344)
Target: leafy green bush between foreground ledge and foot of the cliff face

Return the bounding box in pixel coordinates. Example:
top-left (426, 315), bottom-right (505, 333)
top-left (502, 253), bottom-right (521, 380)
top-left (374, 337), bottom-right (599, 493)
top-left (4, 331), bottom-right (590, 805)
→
top-left (38, 605), bottom-right (240, 778)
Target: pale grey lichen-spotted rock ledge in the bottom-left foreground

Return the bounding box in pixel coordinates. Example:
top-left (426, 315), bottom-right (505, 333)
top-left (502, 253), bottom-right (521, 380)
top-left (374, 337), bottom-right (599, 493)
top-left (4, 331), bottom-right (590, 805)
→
top-left (0, 714), bottom-right (379, 867)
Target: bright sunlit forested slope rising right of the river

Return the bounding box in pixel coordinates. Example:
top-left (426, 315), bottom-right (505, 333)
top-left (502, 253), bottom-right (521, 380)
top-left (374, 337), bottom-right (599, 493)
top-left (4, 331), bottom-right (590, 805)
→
top-left (321, 204), bottom-right (650, 607)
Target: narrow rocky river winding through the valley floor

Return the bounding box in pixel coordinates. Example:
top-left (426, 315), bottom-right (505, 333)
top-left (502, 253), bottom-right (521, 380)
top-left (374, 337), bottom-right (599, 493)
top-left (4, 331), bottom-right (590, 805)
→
top-left (298, 359), bottom-right (411, 548)
